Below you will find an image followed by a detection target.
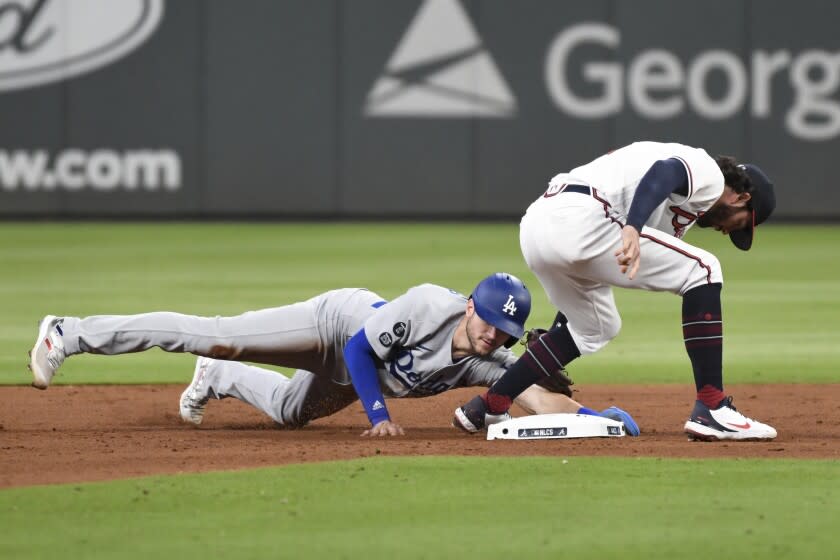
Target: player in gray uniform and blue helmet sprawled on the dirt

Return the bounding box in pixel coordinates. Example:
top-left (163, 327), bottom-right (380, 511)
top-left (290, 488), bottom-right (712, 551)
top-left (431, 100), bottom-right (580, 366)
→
top-left (29, 273), bottom-right (639, 436)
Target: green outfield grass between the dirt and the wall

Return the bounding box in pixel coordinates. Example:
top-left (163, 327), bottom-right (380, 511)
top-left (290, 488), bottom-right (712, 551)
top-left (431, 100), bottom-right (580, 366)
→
top-left (0, 223), bottom-right (840, 384)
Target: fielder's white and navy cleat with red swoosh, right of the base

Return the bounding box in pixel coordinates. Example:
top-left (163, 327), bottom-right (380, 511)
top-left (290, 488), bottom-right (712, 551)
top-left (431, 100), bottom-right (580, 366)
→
top-left (684, 397), bottom-right (776, 441)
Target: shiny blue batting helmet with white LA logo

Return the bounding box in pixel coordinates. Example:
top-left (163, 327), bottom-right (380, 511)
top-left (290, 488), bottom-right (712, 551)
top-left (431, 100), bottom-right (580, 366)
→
top-left (470, 272), bottom-right (531, 347)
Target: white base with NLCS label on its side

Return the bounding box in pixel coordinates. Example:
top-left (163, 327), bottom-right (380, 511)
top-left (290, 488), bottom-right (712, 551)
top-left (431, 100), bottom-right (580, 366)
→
top-left (487, 414), bottom-right (625, 440)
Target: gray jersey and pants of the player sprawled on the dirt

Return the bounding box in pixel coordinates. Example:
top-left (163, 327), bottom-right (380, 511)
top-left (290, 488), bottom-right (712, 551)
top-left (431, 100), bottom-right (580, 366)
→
top-left (63, 284), bottom-right (516, 426)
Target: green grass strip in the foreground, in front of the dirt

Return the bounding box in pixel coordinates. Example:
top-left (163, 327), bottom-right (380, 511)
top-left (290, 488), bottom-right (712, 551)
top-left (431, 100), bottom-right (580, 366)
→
top-left (0, 457), bottom-right (840, 560)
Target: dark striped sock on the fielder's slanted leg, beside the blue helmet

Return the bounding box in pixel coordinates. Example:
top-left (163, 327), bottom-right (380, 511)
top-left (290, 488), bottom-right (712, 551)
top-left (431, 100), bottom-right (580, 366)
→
top-left (484, 325), bottom-right (580, 414)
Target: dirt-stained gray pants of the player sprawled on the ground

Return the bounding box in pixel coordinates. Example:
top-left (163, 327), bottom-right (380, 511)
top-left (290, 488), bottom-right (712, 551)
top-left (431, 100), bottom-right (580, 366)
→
top-left (63, 295), bottom-right (360, 427)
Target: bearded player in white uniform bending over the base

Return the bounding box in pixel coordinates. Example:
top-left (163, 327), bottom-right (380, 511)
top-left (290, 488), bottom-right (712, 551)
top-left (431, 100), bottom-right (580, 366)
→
top-left (454, 142), bottom-right (776, 440)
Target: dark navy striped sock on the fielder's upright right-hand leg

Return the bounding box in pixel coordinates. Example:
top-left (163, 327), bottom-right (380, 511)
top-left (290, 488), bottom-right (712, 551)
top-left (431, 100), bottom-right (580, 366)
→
top-left (682, 284), bottom-right (726, 408)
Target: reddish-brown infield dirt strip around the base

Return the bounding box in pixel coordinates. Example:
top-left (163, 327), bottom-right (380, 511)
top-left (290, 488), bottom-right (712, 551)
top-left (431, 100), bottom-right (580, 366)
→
top-left (0, 384), bottom-right (840, 487)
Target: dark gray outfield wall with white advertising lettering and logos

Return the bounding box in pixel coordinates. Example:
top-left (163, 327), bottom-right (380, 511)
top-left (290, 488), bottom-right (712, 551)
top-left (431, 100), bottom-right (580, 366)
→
top-left (0, 0), bottom-right (840, 219)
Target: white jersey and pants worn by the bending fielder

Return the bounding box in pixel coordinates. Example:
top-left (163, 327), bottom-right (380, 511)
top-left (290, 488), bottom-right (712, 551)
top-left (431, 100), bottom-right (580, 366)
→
top-left (520, 142), bottom-right (724, 354)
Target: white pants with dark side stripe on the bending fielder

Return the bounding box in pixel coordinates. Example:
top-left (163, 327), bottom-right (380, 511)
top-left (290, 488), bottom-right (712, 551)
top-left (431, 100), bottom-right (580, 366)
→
top-left (519, 186), bottom-right (723, 355)
